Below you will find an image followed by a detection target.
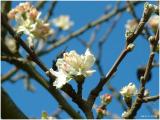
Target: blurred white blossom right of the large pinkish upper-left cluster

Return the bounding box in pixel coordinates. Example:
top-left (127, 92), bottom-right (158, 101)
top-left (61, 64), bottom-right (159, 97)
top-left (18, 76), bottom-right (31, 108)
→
top-left (53, 15), bottom-right (73, 30)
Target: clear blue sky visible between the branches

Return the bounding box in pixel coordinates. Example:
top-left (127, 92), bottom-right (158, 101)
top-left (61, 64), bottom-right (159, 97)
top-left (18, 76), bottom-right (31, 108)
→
top-left (2, 1), bottom-right (159, 118)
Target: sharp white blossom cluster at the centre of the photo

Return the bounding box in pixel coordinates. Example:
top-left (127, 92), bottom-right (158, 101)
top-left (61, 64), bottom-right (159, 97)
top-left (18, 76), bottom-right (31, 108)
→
top-left (50, 49), bottom-right (95, 88)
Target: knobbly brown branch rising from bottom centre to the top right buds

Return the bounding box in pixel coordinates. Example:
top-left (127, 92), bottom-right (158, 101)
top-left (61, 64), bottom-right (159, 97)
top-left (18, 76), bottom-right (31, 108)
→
top-left (87, 1), bottom-right (152, 108)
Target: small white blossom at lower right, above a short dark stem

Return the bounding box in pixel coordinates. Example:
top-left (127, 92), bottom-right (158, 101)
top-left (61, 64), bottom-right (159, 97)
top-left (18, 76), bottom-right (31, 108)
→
top-left (120, 83), bottom-right (137, 97)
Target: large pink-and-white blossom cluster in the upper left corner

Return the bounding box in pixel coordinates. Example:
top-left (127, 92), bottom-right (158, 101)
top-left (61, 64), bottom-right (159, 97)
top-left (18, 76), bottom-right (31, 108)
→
top-left (8, 2), bottom-right (53, 40)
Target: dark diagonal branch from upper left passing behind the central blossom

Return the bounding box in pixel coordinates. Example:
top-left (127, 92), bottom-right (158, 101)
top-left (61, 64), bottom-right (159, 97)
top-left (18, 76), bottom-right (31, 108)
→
top-left (2, 11), bottom-right (93, 118)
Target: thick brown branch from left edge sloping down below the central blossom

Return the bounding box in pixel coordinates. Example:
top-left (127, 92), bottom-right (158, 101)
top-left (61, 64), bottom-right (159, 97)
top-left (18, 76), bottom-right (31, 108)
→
top-left (3, 56), bottom-right (82, 118)
